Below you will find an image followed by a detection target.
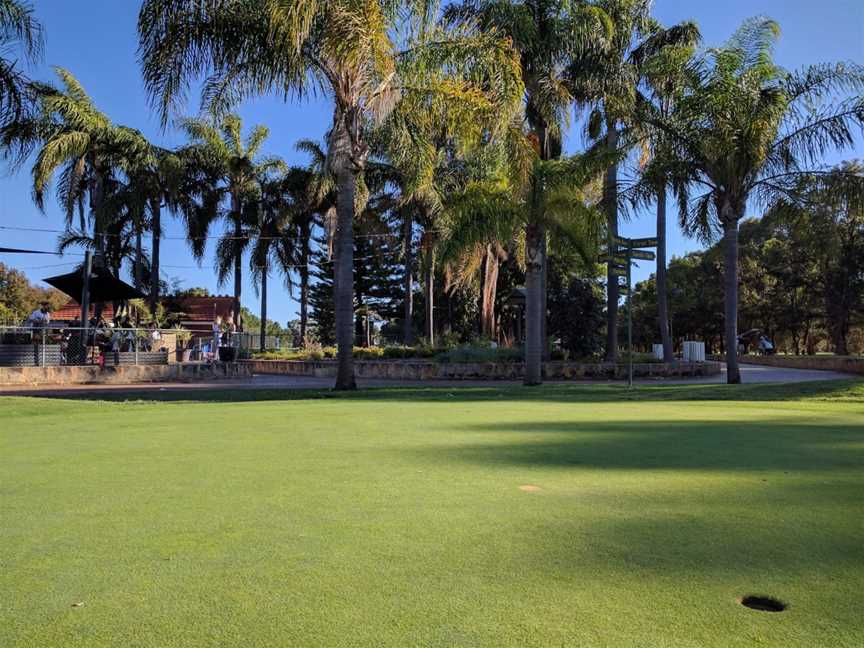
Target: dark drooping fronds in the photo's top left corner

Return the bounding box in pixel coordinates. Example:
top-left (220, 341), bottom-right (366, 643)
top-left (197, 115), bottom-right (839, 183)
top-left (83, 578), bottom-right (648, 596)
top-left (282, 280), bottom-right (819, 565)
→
top-left (0, 0), bottom-right (44, 127)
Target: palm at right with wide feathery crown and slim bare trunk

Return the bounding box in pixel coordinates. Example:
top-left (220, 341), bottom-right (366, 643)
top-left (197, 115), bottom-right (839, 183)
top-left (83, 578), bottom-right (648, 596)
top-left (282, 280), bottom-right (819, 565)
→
top-left (639, 18), bottom-right (864, 383)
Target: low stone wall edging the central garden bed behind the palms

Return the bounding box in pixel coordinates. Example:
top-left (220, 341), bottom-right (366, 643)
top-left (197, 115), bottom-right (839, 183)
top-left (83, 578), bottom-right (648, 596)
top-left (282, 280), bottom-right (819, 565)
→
top-left (242, 360), bottom-right (720, 380)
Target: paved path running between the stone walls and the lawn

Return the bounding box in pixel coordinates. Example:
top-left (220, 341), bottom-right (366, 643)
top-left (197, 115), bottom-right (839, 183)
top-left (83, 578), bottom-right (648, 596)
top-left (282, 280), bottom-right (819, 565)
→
top-left (0, 365), bottom-right (854, 396)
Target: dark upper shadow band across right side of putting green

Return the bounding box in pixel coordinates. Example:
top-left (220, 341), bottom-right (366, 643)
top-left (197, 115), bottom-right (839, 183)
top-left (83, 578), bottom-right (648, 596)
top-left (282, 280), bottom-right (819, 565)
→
top-left (412, 420), bottom-right (864, 472)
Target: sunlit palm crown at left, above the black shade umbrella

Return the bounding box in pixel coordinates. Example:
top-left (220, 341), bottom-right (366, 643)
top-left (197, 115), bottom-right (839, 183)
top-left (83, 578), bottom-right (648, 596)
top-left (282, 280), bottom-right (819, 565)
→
top-left (2, 67), bottom-right (148, 252)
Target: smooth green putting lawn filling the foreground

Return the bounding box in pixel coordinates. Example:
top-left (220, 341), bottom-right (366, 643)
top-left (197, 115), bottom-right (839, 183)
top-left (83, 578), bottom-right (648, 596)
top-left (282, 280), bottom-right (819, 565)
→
top-left (0, 381), bottom-right (864, 648)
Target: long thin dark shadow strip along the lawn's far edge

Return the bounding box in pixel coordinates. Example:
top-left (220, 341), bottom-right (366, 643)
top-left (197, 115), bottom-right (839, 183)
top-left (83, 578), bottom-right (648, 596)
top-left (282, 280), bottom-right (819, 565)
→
top-left (6, 379), bottom-right (864, 403)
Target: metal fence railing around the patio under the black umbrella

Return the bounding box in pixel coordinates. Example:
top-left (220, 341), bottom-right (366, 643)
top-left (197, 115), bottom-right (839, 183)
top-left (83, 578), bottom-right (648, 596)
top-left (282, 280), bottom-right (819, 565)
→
top-left (0, 325), bottom-right (246, 367)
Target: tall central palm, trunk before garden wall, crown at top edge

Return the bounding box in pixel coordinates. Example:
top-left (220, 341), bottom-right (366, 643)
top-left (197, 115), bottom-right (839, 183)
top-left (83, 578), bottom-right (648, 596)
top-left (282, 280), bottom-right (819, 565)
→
top-left (445, 0), bottom-right (613, 385)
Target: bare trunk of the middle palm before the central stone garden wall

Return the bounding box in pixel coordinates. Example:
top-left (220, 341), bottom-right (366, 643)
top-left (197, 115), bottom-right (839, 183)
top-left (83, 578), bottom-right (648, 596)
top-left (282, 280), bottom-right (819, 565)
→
top-left (524, 224), bottom-right (545, 385)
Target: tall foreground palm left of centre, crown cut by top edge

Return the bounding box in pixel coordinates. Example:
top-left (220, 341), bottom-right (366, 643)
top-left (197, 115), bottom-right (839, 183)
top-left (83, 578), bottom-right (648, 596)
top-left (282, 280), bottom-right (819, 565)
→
top-left (138, 0), bottom-right (521, 389)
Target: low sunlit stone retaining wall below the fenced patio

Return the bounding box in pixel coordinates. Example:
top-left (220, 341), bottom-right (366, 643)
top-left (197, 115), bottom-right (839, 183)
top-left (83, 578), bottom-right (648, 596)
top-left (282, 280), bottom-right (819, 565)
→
top-left (0, 362), bottom-right (252, 385)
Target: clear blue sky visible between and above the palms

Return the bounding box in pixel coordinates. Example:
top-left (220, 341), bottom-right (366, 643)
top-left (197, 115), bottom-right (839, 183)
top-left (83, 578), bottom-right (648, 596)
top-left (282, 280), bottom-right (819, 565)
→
top-left (0, 0), bottom-right (864, 323)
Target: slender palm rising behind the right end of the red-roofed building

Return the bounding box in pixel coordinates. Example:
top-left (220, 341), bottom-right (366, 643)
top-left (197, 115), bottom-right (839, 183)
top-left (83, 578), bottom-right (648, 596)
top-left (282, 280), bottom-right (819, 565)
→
top-left (180, 114), bottom-right (285, 331)
